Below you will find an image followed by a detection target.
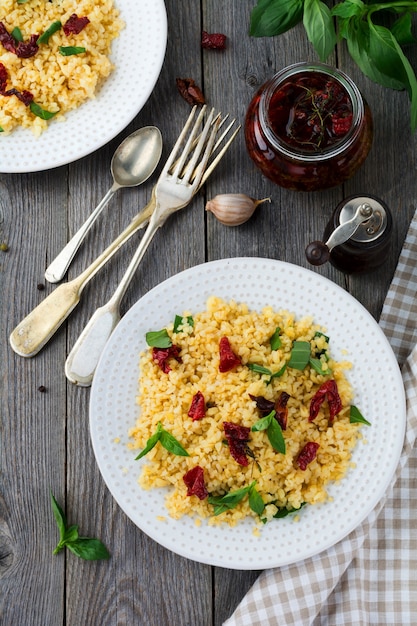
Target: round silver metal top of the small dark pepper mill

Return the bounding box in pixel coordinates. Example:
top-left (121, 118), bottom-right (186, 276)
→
top-left (339, 196), bottom-right (387, 243)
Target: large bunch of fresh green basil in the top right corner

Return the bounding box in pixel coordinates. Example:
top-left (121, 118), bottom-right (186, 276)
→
top-left (249, 0), bottom-right (417, 130)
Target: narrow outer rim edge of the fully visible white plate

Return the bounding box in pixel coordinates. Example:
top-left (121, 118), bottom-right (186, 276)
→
top-left (89, 257), bottom-right (406, 570)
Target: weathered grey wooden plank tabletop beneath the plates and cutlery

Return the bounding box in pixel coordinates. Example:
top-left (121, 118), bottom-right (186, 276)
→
top-left (0, 0), bottom-right (417, 626)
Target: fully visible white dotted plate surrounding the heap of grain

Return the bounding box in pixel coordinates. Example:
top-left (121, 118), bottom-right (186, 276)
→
top-left (90, 258), bottom-right (406, 570)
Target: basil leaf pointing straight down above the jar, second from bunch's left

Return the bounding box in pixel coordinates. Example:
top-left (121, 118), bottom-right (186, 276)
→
top-left (303, 0), bottom-right (337, 61)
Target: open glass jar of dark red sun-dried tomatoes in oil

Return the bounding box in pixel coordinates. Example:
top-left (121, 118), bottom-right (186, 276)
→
top-left (245, 63), bottom-right (373, 191)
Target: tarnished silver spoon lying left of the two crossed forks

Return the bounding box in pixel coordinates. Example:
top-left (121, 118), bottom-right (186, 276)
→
top-left (45, 126), bottom-right (162, 283)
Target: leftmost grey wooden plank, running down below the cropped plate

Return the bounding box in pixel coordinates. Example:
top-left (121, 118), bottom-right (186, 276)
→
top-left (0, 173), bottom-right (66, 624)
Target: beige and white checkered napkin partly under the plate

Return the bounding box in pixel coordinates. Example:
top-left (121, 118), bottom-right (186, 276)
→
top-left (224, 211), bottom-right (417, 626)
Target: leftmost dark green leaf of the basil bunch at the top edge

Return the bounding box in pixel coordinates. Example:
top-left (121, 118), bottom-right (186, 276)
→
top-left (249, 0), bottom-right (304, 37)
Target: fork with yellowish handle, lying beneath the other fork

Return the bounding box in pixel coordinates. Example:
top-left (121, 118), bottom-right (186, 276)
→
top-left (10, 109), bottom-right (240, 357)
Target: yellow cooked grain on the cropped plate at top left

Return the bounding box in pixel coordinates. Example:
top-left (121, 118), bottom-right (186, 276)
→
top-left (0, 0), bottom-right (124, 136)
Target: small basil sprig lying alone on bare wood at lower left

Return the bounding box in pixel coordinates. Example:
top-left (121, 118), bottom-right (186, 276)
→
top-left (51, 492), bottom-right (110, 561)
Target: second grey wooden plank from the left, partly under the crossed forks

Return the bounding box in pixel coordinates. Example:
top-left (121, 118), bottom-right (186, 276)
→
top-left (66, 3), bottom-right (212, 626)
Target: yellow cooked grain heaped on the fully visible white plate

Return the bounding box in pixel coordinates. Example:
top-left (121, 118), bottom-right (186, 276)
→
top-left (129, 296), bottom-right (361, 526)
